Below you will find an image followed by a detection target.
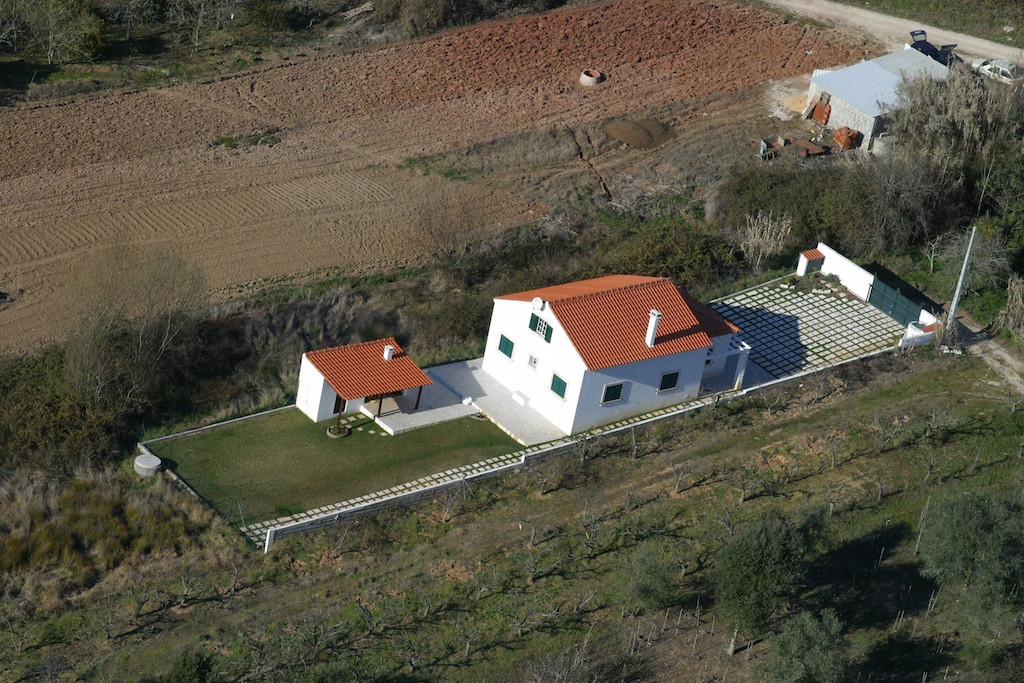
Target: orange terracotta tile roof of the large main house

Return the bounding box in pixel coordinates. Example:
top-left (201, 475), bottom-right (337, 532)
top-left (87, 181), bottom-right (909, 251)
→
top-left (497, 275), bottom-right (738, 370)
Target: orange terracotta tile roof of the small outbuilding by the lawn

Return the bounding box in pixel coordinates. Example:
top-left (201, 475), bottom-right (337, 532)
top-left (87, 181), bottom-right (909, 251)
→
top-left (306, 337), bottom-right (433, 400)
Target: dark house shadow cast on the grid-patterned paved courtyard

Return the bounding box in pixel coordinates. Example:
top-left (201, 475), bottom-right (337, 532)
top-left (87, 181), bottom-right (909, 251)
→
top-left (711, 302), bottom-right (810, 379)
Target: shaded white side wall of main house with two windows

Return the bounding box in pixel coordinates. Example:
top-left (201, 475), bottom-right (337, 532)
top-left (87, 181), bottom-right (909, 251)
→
top-left (568, 348), bottom-right (707, 433)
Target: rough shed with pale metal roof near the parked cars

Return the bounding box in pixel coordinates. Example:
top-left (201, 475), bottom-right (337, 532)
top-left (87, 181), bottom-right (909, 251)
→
top-left (807, 47), bottom-right (949, 150)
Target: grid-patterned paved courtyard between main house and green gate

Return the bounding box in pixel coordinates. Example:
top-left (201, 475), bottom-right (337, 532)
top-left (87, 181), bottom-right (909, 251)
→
top-left (710, 283), bottom-right (904, 387)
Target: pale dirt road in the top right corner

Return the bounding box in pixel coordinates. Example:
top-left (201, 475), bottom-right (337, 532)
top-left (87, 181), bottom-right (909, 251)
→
top-left (765, 0), bottom-right (1024, 61)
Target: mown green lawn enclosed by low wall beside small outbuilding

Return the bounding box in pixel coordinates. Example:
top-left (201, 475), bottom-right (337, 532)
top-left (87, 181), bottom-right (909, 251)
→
top-left (150, 409), bottom-right (520, 523)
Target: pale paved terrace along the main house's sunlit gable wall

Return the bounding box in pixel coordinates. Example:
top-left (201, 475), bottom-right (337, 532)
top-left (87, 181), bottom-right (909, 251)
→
top-left (427, 358), bottom-right (565, 445)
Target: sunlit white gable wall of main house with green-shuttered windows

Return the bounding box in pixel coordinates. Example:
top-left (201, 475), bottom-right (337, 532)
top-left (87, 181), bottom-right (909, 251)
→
top-left (482, 299), bottom-right (586, 434)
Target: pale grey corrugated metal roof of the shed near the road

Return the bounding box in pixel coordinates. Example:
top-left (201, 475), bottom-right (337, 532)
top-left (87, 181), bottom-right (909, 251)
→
top-left (811, 48), bottom-right (949, 117)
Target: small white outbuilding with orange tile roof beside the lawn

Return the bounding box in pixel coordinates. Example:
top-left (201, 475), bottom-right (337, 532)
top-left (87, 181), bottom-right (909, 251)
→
top-left (295, 338), bottom-right (433, 422)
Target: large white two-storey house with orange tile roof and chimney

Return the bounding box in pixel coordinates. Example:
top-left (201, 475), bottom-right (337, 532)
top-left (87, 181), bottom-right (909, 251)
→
top-left (482, 275), bottom-right (750, 434)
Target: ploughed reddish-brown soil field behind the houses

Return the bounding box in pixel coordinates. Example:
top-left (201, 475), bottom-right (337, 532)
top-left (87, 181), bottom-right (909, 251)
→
top-left (0, 0), bottom-right (863, 352)
